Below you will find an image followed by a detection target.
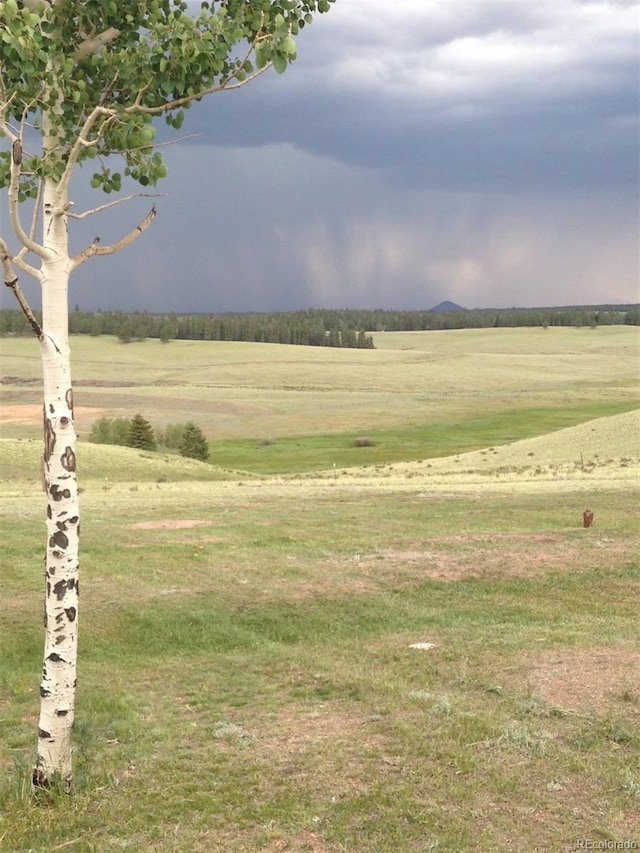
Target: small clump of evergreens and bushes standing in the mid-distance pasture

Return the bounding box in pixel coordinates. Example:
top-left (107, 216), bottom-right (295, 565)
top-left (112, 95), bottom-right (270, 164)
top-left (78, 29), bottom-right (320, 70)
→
top-left (89, 414), bottom-right (209, 462)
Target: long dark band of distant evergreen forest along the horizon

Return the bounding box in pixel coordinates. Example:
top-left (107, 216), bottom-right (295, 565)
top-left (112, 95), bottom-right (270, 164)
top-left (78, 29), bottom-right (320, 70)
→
top-left (0, 305), bottom-right (640, 349)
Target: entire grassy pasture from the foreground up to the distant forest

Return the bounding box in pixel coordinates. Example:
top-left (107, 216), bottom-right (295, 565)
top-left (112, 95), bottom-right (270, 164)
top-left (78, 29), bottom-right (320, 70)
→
top-left (0, 327), bottom-right (640, 853)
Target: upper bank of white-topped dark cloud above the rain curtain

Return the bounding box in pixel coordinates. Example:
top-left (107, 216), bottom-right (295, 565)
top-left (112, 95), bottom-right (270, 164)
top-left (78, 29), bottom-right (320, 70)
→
top-left (181, 0), bottom-right (638, 190)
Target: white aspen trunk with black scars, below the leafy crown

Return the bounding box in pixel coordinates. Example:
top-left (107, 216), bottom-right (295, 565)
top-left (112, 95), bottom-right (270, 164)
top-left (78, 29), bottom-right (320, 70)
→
top-left (33, 176), bottom-right (80, 792)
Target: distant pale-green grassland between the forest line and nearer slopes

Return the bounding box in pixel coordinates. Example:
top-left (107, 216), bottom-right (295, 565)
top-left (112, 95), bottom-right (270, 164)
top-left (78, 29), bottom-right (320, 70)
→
top-left (0, 326), bottom-right (640, 474)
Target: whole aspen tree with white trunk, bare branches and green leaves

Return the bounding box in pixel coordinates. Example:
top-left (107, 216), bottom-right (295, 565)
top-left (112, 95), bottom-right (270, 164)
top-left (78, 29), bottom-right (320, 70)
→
top-left (0, 0), bottom-right (333, 792)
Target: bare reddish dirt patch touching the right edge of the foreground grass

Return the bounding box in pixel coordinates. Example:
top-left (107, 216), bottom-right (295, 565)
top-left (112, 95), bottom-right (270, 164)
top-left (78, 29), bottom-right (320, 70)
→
top-left (518, 648), bottom-right (640, 720)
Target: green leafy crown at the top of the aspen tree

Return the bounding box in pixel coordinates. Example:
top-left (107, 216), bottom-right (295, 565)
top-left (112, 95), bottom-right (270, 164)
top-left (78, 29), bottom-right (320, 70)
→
top-left (0, 0), bottom-right (334, 198)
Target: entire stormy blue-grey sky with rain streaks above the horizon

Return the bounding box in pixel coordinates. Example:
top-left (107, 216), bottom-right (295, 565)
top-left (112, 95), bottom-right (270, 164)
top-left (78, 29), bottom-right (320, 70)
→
top-left (3, 0), bottom-right (640, 312)
